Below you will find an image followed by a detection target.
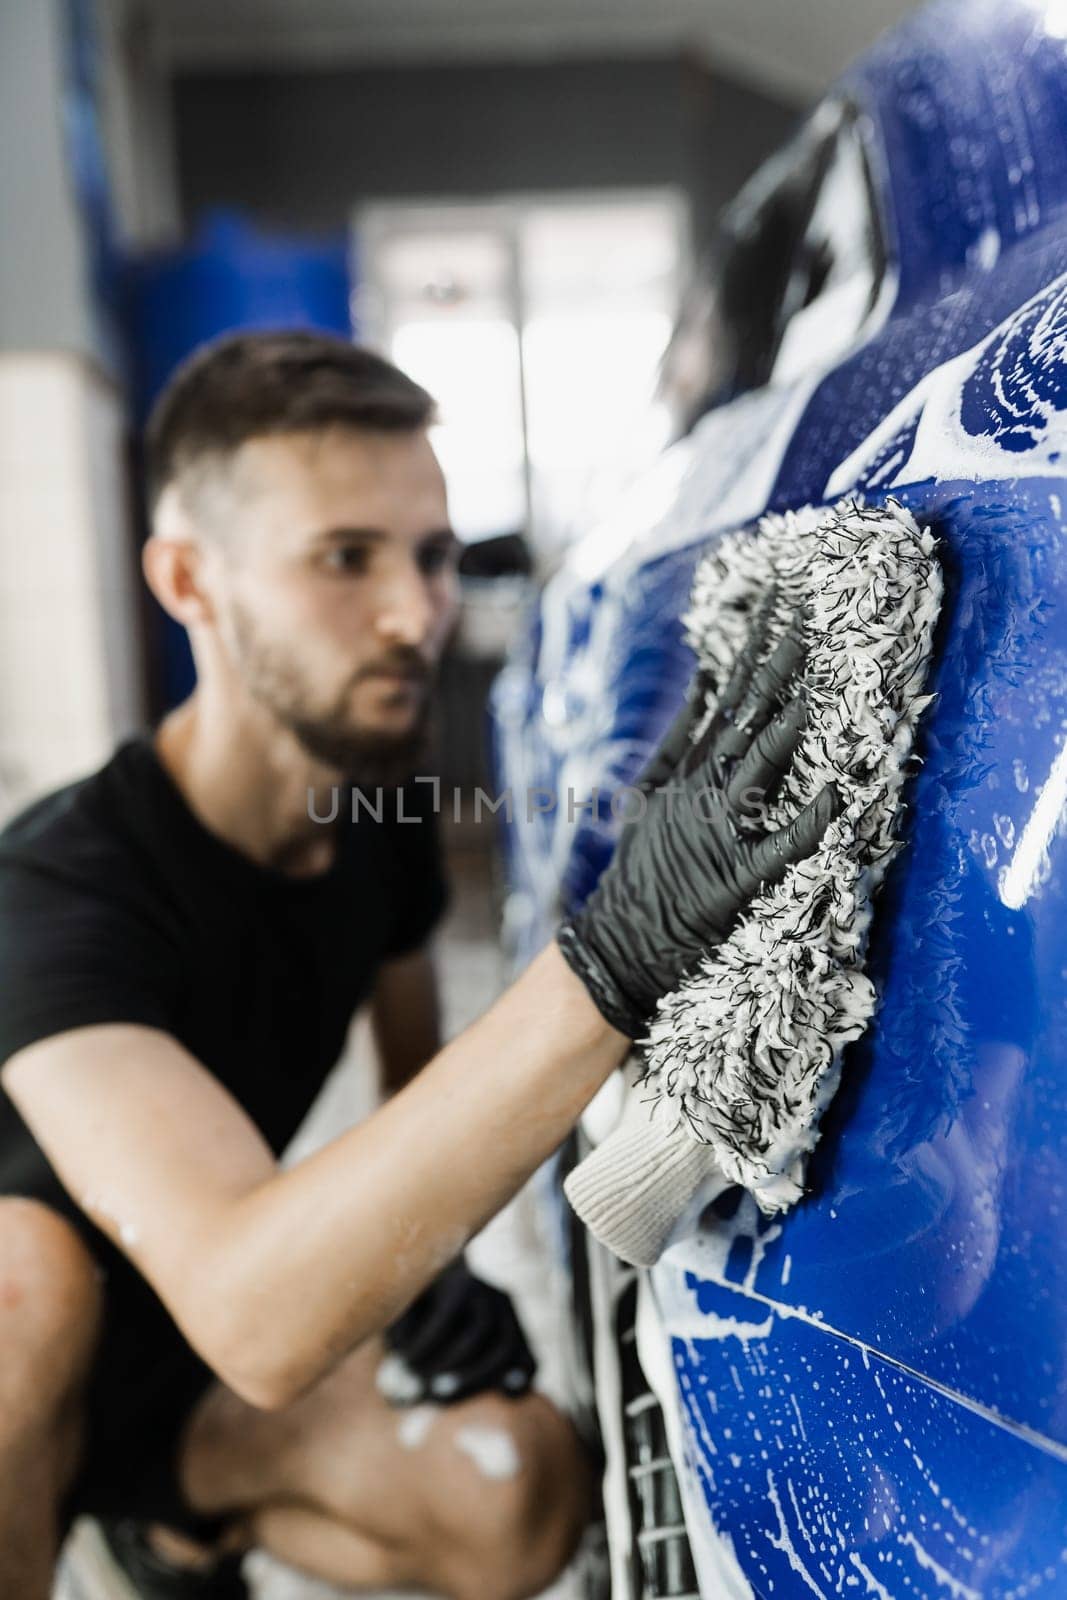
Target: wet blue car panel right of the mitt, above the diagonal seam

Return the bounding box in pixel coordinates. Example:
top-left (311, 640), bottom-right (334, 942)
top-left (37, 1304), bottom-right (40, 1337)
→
top-left (713, 483), bottom-right (1067, 1443)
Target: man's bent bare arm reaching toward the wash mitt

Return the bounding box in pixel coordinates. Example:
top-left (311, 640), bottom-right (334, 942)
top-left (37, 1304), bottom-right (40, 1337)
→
top-left (3, 944), bottom-right (625, 1406)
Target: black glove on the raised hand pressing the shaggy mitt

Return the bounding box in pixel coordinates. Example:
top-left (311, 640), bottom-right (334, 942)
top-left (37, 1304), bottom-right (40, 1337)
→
top-left (557, 597), bottom-right (838, 1038)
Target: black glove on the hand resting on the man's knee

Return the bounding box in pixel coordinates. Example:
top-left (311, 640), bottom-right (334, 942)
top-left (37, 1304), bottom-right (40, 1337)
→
top-left (379, 1261), bottom-right (537, 1405)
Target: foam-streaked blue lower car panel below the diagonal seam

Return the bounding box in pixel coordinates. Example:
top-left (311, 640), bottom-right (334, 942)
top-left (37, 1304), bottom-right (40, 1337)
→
top-left (653, 1269), bottom-right (1067, 1600)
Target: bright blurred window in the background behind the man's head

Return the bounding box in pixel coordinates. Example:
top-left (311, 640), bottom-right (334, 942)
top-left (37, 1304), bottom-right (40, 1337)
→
top-left (357, 190), bottom-right (686, 565)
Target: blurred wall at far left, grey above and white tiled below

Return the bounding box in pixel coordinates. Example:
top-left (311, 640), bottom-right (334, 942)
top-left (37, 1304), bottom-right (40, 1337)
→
top-left (0, 0), bottom-right (142, 818)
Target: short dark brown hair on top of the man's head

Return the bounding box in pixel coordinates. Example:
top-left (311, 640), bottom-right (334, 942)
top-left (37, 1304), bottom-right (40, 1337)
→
top-left (146, 330), bottom-right (434, 507)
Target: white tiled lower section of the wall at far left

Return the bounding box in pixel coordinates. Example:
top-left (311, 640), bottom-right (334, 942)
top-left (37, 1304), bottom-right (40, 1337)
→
top-left (0, 350), bottom-right (141, 818)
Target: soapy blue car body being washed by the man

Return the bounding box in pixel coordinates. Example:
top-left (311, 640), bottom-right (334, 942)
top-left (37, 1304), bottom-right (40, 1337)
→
top-left (494, 0), bottom-right (1067, 1600)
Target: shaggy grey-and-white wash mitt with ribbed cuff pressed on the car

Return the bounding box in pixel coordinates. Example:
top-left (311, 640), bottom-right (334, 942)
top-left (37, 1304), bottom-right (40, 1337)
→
top-left (566, 499), bottom-right (942, 1266)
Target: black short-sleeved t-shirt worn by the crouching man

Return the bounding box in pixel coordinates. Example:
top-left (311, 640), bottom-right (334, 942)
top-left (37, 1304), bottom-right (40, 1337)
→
top-left (0, 738), bottom-right (446, 1190)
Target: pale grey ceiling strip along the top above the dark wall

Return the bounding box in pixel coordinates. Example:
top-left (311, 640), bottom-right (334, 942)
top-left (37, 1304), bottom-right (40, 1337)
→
top-left (146, 0), bottom-right (917, 102)
